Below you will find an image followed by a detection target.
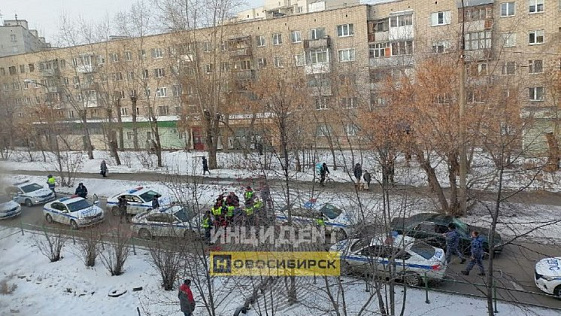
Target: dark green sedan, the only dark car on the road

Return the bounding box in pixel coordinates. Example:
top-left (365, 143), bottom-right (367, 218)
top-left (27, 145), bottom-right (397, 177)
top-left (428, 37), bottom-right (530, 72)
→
top-left (391, 213), bottom-right (503, 255)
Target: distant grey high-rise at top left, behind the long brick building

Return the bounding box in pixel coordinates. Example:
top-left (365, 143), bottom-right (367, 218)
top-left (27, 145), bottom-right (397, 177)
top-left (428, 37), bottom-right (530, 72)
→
top-left (0, 16), bottom-right (51, 57)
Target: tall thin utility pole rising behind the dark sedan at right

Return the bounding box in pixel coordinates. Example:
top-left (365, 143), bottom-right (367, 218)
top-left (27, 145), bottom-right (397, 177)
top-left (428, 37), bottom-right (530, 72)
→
top-left (458, 0), bottom-right (467, 215)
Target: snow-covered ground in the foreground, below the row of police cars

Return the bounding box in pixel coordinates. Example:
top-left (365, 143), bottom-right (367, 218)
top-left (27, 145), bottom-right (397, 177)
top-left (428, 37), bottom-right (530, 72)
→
top-left (0, 229), bottom-right (559, 316)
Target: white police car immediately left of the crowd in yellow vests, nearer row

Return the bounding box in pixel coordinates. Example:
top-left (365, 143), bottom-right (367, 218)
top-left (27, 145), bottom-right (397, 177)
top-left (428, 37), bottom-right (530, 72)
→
top-left (131, 205), bottom-right (200, 239)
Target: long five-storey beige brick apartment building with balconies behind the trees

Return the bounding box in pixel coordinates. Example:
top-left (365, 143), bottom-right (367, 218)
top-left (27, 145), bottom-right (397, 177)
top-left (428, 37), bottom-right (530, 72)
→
top-left (0, 0), bottom-right (561, 153)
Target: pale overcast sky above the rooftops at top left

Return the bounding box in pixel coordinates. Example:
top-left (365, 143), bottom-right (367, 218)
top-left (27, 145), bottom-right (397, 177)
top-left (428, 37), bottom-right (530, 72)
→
top-left (0, 0), bottom-right (258, 44)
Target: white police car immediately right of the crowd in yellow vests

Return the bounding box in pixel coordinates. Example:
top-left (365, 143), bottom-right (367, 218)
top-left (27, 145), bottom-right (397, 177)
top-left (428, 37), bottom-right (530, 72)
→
top-left (275, 201), bottom-right (353, 240)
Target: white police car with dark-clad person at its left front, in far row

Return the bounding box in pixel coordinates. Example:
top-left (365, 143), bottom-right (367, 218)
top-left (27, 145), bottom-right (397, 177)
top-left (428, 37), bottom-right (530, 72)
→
top-left (106, 187), bottom-right (171, 216)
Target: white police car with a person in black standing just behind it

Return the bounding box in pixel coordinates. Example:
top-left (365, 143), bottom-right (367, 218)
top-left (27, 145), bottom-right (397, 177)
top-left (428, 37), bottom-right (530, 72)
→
top-left (43, 196), bottom-right (104, 229)
